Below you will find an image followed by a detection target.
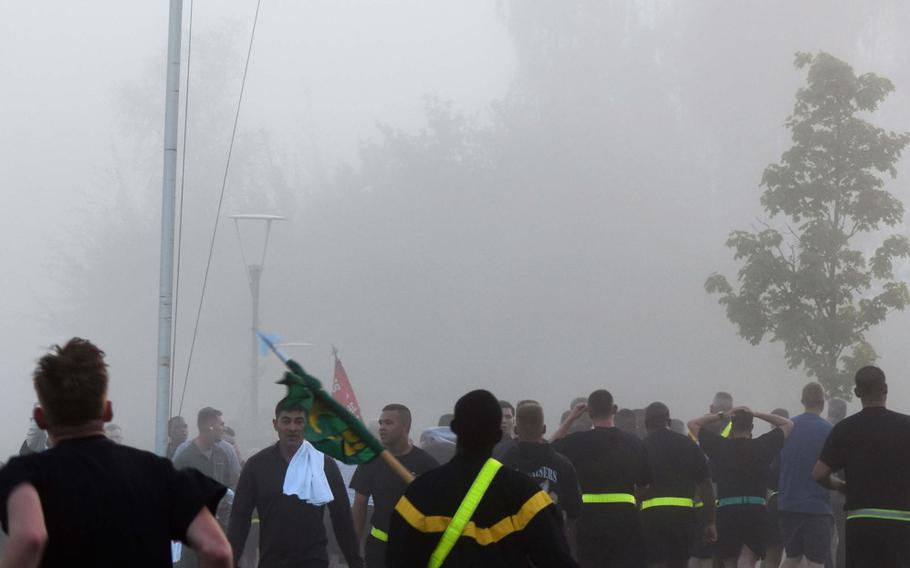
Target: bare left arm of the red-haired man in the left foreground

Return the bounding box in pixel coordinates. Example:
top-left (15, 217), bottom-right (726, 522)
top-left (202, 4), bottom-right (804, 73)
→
top-left (0, 483), bottom-right (47, 568)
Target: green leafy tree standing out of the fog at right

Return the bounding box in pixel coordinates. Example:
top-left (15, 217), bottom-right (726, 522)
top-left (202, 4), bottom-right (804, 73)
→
top-left (705, 53), bottom-right (910, 397)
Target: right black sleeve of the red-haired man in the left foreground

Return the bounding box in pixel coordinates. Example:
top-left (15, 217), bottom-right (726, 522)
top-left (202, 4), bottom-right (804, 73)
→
top-left (170, 460), bottom-right (227, 542)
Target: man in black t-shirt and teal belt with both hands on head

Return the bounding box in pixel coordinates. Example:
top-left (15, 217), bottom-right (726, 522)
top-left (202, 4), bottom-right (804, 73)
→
top-left (689, 406), bottom-right (793, 567)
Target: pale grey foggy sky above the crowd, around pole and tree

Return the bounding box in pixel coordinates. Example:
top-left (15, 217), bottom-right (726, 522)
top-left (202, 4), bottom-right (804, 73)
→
top-left (0, 0), bottom-right (910, 454)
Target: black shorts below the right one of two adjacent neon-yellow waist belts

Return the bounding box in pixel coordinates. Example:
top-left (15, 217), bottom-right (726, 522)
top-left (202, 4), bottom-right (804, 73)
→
top-left (641, 507), bottom-right (695, 568)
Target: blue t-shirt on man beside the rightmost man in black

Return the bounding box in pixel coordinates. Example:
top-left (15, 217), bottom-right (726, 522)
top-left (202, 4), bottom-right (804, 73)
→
top-left (777, 412), bottom-right (831, 515)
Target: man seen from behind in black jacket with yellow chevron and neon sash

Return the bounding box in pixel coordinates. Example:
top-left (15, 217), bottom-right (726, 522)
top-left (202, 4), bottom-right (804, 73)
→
top-left (386, 390), bottom-right (576, 568)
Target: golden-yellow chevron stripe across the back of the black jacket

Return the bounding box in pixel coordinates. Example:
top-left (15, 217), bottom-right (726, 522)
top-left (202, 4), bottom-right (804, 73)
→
top-left (395, 491), bottom-right (553, 546)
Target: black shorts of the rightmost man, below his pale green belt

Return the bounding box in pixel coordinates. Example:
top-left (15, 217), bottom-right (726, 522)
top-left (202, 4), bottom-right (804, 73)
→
top-left (847, 513), bottom-right (910, 568)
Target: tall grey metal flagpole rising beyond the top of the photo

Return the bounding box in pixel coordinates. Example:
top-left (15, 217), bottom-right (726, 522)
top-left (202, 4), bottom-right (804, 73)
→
top-left (155, 0), bottom-right (183, 456)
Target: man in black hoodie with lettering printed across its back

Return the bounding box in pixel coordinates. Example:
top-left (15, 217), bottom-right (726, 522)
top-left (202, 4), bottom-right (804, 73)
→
top-left (502, 401), bottom-right (581, 520)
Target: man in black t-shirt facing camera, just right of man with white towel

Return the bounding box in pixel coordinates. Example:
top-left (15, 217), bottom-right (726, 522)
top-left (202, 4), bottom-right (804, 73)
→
top-left (350, 404), bottom-right (439, 568)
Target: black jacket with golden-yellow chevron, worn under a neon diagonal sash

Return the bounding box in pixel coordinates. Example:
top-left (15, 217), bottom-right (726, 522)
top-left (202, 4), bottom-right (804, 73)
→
top-left (386, 455), bottom-right (577, 568)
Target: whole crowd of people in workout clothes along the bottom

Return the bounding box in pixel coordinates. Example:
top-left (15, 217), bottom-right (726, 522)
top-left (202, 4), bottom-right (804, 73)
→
top-left (0, 338), bottom-right (910, 568)
